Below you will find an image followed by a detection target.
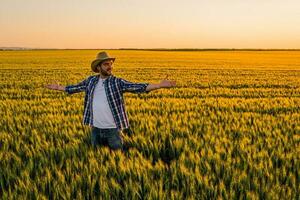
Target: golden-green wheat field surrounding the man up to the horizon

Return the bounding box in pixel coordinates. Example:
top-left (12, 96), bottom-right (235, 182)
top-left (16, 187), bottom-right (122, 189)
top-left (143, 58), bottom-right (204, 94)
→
top-left (0, 50), bottom-right (300, 199)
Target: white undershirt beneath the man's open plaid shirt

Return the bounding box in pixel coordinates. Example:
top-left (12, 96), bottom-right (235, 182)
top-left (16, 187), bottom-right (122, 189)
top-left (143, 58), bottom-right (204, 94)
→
top-left (93, 77), bottom-right (117, 128)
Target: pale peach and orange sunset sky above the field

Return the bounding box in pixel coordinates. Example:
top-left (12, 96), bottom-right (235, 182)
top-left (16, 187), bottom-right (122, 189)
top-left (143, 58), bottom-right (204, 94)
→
top-left (0, 0), bottom-right (300, 49)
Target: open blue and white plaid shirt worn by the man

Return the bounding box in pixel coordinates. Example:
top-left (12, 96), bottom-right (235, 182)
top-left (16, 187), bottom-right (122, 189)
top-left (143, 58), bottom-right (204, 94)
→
top-left (65, 75), bottom-right (149, 131)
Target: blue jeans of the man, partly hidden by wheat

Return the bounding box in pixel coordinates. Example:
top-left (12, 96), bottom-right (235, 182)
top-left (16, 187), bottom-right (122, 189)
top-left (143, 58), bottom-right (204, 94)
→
top-left (91, 127), bottom-right (123, 150)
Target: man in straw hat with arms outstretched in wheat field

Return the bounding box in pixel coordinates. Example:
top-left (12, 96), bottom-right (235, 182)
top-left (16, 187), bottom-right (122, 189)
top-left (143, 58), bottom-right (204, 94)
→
top-left (46, 52), bottom-right (176, 150)
